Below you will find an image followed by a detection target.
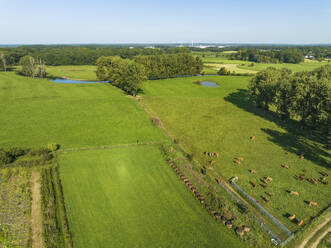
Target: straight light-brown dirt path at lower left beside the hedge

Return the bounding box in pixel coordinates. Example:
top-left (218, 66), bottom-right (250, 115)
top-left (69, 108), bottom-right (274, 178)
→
top-left (31, 171), bottom-right (43, 248)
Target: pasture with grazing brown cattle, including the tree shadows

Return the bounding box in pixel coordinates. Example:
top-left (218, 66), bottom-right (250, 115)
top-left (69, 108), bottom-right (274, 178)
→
top-left (143, 76), bottom-right (331, 231)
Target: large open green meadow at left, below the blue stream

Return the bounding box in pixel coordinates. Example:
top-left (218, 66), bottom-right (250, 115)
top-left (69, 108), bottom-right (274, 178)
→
top-left (0, 72), bottom-right (167, 148)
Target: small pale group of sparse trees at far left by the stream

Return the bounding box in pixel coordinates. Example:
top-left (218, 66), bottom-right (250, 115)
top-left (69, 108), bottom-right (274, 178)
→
top-left (19, 56), bottom-right (46, 78)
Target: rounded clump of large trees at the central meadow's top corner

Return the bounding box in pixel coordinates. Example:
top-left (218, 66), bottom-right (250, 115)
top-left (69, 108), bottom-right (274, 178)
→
top-left (96, 56), bottom-right (147, 95)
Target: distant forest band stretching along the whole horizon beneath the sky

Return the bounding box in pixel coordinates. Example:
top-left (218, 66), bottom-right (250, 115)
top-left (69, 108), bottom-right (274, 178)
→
top-left (0, 45), bottom-right (331, 66)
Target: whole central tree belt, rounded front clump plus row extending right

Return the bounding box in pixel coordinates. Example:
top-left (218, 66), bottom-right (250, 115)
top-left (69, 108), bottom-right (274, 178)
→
top-left (96, 54), bottom-right (203, 95)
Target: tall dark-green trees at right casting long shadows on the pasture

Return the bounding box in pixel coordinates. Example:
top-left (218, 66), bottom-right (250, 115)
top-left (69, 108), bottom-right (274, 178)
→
top-left (248, 65), bottom-right (331, 128)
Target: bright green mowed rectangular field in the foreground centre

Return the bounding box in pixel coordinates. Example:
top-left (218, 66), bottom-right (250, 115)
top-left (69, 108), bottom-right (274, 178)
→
top-left (59, 146), bottom-right (244, 248)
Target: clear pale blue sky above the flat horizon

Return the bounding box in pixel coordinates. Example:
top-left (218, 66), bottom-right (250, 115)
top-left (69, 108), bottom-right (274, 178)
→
top-left (0, 0), bottom-right (331, 44)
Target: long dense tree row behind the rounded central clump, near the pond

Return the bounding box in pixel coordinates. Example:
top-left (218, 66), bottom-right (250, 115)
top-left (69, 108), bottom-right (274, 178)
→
top-left (134, 53), bottom-right (203, 79)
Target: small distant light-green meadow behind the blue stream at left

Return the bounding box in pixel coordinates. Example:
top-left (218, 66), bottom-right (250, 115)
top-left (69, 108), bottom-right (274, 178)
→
top-left (46, 65), bottom-right (98, 81)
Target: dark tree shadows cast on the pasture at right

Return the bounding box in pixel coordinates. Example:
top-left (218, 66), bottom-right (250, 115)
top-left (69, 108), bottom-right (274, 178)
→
top-left (224, 89), bottom-right (331, 169)
